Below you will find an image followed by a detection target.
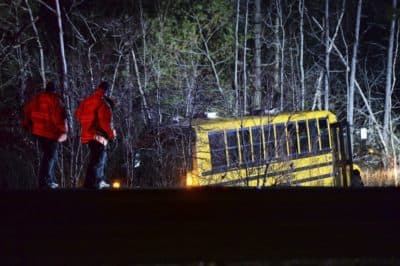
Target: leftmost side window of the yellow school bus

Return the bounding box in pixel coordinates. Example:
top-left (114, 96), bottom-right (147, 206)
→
top-left (208, 131), bottom-right (226, 169)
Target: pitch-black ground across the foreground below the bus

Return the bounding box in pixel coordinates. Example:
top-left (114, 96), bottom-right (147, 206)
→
top-left (0, 188), bottom-right (400, 265)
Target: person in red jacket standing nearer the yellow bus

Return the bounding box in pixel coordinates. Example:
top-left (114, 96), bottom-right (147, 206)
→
top-left (75, 81), bottom-right (116, 189)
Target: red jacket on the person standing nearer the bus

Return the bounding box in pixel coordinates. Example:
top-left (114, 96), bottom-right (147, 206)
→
top-left (75, 88), bottom-right (115, 143)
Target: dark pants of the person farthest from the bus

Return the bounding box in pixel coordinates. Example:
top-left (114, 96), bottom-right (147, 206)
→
top-left (37, 137), bottom-right (58, 188)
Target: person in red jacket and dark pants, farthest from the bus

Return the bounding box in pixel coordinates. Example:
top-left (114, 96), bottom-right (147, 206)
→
top-left (22, 82), bottom-right (68, 189)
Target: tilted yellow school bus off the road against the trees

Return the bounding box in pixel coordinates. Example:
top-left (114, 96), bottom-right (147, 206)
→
top-left (137, 111), bottom-right (353, 187)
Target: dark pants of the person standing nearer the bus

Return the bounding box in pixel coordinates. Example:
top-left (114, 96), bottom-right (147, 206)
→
top-left (83, 140), bottom-right (107, 188)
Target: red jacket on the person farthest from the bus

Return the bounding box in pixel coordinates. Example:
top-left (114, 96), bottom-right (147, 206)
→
top-left (22, 91), bottom-right (68, 140)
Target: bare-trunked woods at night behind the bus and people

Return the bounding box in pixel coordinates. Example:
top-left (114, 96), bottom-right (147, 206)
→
top-left (0, 0), bottom-right (400, 189)
